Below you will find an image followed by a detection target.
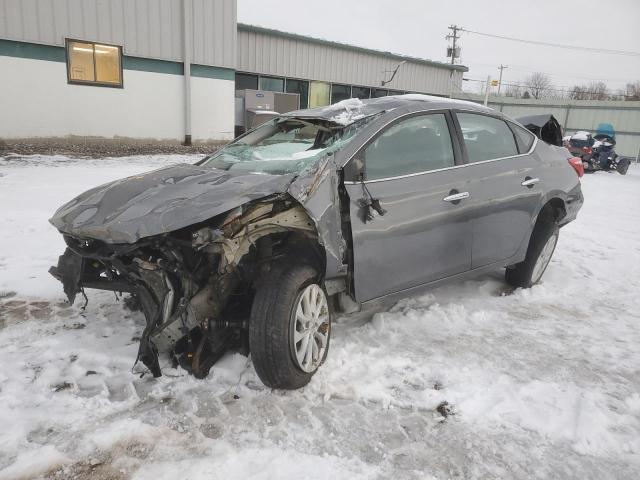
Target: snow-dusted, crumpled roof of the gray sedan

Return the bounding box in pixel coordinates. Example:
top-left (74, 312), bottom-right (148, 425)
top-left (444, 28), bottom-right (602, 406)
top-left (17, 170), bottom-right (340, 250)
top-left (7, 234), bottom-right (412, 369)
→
top-left (282, 93), bottom-right (497, 125)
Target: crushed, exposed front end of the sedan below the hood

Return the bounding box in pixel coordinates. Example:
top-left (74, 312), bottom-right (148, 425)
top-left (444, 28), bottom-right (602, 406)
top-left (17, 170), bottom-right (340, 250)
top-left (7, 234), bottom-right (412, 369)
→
top-left (50, 194), bottom-right (316, 377)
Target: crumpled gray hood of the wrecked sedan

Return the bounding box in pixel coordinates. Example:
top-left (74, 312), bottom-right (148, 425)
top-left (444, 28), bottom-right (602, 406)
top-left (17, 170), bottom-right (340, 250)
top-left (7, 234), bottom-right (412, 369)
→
top-left (49, 164), bottom-right (293, 243)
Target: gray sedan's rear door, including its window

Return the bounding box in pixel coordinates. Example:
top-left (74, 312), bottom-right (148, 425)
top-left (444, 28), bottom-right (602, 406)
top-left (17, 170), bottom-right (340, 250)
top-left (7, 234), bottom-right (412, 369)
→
top-left (456, 112), bottom-right (541, 269)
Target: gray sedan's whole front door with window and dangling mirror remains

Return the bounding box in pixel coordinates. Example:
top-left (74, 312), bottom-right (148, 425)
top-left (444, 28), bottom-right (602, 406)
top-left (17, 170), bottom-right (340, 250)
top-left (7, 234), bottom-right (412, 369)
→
top-left (345, 111), bottom-right (471, 302)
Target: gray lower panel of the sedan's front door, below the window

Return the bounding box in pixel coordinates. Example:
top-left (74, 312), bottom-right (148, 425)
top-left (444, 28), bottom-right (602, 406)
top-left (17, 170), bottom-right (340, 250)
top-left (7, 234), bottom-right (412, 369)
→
top-left (346, 169), bottom-right (471, 302)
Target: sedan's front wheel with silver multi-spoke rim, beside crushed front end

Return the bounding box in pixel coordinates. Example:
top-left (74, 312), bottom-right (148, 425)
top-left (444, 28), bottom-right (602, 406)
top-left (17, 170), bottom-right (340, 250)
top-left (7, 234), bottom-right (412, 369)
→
top-left (249, 260), bottom-right (331, 390)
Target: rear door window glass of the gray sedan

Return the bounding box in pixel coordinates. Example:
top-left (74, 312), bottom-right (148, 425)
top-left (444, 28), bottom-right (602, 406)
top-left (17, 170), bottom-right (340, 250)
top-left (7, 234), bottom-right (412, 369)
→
top-left (456, 113), bottom-right (518, 163)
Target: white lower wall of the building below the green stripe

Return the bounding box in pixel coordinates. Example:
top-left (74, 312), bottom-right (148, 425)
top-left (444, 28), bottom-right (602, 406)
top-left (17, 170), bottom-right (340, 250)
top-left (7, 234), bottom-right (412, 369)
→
top-left (0, 56), bottom-right (234, 141)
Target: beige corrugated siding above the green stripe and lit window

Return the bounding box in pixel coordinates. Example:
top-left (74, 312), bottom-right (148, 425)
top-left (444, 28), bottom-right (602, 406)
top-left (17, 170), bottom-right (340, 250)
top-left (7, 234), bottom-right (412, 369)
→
top-left (0, 0), bottom-right (228, 64)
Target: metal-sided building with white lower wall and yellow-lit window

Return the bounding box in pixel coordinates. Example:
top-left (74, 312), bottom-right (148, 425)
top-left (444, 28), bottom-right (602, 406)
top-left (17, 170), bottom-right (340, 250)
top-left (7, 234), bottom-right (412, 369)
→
top-left (0, 0), bottom-right (467, 141)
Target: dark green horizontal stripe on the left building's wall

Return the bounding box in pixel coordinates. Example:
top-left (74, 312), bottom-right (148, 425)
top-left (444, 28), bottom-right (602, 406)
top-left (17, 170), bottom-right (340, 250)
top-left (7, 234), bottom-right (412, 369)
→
top-left (0, 39), bottom-right (235, 81)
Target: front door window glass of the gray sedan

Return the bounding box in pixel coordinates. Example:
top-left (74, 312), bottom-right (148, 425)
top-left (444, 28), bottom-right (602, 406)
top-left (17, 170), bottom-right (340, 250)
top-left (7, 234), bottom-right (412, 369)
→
top-left (364, 113), bottom-right (454, 180)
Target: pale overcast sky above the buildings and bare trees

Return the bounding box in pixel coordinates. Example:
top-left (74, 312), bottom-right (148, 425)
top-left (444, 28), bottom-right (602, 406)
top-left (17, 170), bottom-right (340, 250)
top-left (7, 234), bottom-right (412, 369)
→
top-left (238, 0), bottom-right (640, 95)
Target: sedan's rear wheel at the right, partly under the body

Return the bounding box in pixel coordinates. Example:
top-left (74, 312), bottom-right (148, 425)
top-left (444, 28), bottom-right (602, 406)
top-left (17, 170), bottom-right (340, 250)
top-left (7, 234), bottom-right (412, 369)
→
top-left (505, 219), bottom-right (559, 288)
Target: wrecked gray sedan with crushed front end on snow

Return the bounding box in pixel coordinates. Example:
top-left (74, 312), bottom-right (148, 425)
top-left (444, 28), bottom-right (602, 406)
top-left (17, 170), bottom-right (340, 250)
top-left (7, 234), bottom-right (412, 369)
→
top-left (51, 95), bottom-right (583, 389)
